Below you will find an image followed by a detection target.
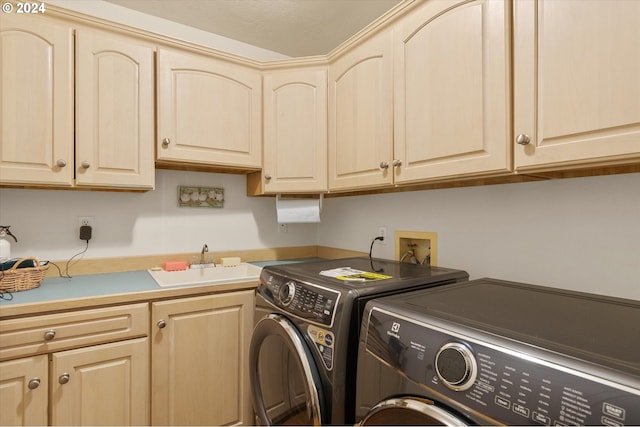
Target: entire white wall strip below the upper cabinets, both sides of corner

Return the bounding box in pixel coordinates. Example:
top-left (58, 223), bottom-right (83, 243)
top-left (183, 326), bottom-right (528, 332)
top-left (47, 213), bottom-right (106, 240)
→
top-left (0, 171), bottom-right (640, 300)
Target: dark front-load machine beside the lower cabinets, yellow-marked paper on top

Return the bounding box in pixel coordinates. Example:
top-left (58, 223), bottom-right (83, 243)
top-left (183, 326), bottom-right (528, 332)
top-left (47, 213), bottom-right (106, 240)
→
top-left (249, 257), bottom-right (468, 425)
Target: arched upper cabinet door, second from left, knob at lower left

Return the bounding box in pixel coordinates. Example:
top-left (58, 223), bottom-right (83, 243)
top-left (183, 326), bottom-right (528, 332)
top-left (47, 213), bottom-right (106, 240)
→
top-left (76, 29), bottom-right (155, 189)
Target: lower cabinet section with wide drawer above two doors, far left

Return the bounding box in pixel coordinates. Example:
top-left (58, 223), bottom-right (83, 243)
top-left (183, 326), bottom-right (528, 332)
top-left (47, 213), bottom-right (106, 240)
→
top-left (0, 303), bottom-right (150, 426)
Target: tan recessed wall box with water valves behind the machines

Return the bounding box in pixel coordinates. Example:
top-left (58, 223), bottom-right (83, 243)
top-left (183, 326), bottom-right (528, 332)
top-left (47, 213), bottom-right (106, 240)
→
top-left (395, 230), bottom-right (438, 266)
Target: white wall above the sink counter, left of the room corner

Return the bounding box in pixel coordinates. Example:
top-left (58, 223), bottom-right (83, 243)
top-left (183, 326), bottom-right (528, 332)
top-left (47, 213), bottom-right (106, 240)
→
top-left (0, 170), bottom-right (318, 260)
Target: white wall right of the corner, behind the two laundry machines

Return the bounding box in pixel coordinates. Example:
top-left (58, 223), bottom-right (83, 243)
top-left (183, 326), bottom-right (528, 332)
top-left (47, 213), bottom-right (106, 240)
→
top-left (318, 174), bottom-right (640, 300)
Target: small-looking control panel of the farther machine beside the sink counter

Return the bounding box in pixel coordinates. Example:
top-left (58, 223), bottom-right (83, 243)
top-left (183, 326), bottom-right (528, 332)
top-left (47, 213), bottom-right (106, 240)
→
top-left (257, 270), bottom-right (340, 327)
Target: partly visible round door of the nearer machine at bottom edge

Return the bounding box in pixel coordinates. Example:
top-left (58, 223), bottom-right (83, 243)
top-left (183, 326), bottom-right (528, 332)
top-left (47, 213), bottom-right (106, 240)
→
top-left (358, 396), bottom-right (468, 426)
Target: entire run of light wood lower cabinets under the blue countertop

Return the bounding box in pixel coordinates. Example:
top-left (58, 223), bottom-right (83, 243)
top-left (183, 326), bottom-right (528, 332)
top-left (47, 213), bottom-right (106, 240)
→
top-left (0, 290), bottom-right (254, 426)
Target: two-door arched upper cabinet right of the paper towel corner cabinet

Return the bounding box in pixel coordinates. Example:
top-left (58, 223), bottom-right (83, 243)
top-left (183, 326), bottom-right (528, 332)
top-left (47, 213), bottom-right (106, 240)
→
top-left (328, 0), bottom-right (512, 194)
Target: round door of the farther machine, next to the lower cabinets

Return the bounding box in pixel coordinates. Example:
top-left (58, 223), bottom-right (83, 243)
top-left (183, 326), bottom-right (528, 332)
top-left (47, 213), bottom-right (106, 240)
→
top-left (249, 314), bottom-right (325, 425)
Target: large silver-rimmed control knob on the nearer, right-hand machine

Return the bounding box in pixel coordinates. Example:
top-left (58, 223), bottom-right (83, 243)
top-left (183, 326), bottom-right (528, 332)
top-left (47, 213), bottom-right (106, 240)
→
top-left (435, 342), bottom-right (478, 391)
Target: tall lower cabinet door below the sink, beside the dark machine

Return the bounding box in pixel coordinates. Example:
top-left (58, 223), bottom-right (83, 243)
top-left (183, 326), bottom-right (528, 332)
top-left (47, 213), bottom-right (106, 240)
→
top-left (151, 291), bottom-right (253, 425)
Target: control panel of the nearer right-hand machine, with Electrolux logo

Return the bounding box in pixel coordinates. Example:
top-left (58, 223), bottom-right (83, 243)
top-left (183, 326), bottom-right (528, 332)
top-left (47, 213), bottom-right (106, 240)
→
top-left (365, 307), bottom-right (640, 425)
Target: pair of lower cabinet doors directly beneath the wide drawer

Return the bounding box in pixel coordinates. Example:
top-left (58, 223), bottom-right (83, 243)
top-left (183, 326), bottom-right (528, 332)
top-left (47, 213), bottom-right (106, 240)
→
top-left (0, 338), bottom-right (149, 426)
